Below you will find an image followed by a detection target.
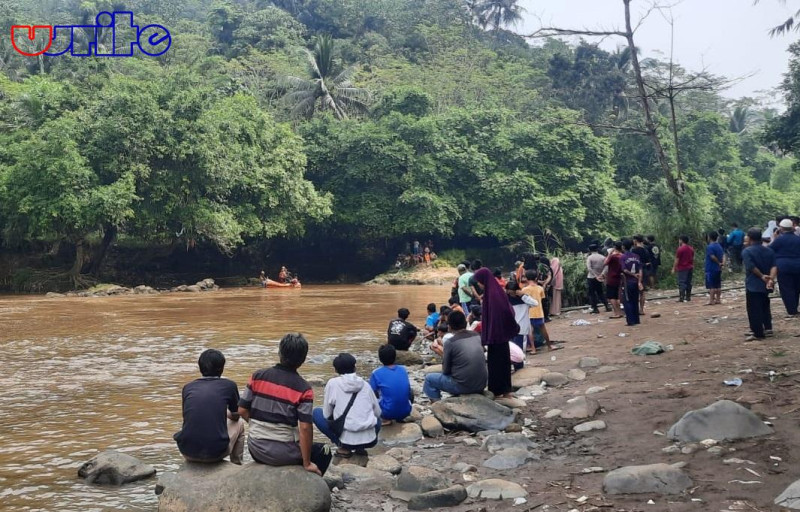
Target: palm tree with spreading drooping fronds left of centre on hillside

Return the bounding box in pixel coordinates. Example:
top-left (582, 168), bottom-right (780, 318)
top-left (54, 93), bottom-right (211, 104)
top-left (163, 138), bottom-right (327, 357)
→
top-left (283, 35), bottom-right (370, 119)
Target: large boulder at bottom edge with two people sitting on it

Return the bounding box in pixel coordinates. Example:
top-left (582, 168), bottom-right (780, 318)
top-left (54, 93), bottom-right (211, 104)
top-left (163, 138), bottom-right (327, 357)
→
top-left (158, 462), bottom-right (331, 512)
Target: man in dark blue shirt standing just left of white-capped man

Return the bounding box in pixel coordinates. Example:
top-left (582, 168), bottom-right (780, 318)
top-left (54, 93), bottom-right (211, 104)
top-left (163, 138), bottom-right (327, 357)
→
top-left (742, 228), bottom-right (778, 341)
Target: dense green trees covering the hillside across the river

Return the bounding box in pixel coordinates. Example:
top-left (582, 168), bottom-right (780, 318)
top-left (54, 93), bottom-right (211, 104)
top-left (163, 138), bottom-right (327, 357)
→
top-left (0, 0), bottom-right (800, 284)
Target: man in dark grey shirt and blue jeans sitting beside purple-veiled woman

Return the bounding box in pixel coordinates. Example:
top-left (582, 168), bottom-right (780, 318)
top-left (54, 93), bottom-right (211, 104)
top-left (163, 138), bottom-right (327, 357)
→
top-left (422, 312), bottom-right (488, 402)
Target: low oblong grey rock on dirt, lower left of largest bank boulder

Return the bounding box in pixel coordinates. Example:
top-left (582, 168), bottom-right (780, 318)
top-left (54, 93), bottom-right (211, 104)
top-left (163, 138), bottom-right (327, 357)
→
top-left (603, 464), bottom-right (692, 494)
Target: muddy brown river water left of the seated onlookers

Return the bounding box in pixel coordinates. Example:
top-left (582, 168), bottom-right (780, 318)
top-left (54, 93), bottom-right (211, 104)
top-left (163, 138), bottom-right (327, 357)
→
top-left (0, 286), bottom-right (449, 512)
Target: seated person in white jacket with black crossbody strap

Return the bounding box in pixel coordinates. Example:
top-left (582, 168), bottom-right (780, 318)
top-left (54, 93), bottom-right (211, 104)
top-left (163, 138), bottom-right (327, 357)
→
top-left (313, 352), bottom-right (381, 459)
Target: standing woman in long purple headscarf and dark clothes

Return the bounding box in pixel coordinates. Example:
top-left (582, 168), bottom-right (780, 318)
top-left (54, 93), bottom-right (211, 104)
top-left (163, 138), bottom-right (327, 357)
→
top-left (474, 268), bottom-right (519, 397)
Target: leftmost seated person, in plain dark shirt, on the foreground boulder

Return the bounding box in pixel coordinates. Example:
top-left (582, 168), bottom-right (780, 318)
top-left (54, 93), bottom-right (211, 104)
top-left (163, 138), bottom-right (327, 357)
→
top-left (172, 349), bottom-right (244, 464)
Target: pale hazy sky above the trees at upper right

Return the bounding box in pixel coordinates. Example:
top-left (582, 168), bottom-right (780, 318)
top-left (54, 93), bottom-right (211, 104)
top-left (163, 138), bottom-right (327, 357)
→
top-left (516, 0), bottom-right (800, 104)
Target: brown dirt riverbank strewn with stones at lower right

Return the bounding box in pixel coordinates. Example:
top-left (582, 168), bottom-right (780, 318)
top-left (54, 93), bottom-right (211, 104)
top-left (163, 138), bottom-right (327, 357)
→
top-left (340, 284), bottom-right (800, 512)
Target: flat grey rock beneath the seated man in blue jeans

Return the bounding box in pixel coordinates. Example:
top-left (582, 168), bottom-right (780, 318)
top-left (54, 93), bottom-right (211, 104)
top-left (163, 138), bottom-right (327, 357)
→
top-left (431, 395), bottom-right (515, 432)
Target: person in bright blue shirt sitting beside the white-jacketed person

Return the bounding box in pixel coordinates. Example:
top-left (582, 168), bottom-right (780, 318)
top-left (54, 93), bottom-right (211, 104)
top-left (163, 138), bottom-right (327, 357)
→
top-left (369, 345), bottom-right (414, 425)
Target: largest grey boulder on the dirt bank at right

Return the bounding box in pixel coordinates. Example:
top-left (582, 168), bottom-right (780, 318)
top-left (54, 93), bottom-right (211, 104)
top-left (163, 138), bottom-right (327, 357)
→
top-left (667, 400), bottom-right (773, 443)
